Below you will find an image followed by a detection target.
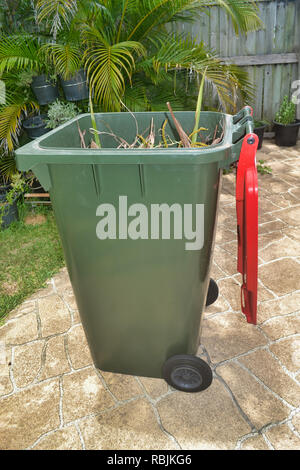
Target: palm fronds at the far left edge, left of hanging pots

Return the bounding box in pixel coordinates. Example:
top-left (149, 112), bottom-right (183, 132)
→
top-left (0, 0), bottom-right (47, 180)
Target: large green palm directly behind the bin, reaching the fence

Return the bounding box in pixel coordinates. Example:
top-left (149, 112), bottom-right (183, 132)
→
top-left (37, 0), bottom-right (262, 111)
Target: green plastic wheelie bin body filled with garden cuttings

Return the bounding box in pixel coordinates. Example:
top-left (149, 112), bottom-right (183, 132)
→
top-left (16, 107), bottom-right (253, 392)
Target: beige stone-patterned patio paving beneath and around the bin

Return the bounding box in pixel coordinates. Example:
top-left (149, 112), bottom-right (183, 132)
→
top-left (0, 141), bottom-right (300, 450)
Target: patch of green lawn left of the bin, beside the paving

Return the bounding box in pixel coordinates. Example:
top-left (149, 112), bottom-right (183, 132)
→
top-left (0, 208), bottom-right (64, 322)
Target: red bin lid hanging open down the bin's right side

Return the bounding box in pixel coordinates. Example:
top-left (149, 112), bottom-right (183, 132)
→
top-left (236, 123), bottom-right (258, 325)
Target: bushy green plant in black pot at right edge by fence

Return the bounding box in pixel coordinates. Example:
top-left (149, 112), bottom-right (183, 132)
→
top-left (274, 96), bottom-right (300, 147)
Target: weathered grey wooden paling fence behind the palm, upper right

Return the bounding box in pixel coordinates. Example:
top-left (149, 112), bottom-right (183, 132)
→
top-left (177, 0), bottom-right (300, 122)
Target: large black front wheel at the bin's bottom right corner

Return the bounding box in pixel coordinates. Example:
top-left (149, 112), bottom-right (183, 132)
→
top-left (163, 354), bottom-right (212, 393)
